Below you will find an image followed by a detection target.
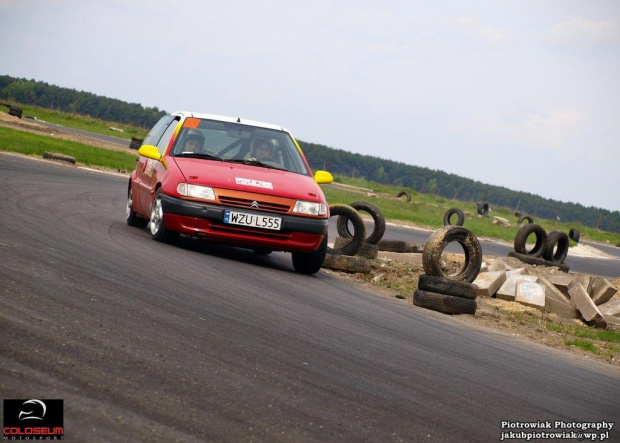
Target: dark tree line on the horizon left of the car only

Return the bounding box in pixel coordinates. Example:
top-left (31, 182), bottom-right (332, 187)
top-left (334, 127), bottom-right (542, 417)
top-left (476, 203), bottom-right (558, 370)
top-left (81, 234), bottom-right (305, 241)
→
top-left (0, 75), bottom-right (166, 128)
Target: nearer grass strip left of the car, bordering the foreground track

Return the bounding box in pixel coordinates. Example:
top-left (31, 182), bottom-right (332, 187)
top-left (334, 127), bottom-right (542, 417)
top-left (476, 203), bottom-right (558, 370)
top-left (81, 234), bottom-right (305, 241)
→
top-left (0, 127), bottom-right (136, 172)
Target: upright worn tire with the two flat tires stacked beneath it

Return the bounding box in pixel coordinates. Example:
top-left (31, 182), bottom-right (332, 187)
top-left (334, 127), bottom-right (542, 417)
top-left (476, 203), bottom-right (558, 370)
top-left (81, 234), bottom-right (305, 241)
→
top-left (413, 225), bottom-right (482, 315)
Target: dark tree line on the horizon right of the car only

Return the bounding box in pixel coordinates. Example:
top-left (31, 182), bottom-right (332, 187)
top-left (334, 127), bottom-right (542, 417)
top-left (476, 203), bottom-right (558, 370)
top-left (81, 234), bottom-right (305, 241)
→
top-left (299, 141), bottom-right (620, 234)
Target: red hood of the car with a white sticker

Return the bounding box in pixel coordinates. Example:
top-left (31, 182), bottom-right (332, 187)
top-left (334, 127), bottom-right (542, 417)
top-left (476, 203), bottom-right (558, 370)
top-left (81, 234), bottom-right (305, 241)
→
top-left (172, 157), bottom-right (322, 201)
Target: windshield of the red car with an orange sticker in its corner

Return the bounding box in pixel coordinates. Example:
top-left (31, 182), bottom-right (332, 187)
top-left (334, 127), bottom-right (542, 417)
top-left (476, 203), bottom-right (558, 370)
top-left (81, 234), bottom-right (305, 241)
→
top-left (172, 118), bottom-right (310, 175)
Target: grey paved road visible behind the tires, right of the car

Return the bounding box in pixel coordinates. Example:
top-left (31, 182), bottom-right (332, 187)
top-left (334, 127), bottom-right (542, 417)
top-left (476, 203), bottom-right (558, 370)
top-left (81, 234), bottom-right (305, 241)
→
top-left (329, 220), bottom-right (620, 278)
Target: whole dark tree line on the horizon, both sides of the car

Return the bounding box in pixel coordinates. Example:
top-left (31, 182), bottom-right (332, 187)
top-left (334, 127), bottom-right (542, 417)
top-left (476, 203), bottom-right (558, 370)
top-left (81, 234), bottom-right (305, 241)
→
top-left (0, 75), bottom-right (620, 233)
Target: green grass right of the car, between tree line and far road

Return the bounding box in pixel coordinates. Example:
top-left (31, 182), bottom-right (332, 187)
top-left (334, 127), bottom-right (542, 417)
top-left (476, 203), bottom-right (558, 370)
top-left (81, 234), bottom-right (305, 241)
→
top-left (323, 176), bottom-right (620, 246)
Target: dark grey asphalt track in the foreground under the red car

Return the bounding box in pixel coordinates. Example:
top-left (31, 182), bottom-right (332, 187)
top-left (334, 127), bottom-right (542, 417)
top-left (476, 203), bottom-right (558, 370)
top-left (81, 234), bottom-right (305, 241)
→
top-left (0, 153), bottom-right (620, 442)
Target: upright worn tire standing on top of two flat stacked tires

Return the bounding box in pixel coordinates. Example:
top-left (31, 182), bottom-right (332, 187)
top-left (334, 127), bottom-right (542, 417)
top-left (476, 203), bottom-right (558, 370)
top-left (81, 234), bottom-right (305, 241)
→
top-left (422, 226), bottom-right (482, 283)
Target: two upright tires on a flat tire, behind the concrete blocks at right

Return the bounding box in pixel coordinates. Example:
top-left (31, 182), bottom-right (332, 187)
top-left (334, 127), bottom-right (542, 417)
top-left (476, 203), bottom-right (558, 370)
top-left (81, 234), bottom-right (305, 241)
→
top-left (508, 223), bottom-right (578, 272)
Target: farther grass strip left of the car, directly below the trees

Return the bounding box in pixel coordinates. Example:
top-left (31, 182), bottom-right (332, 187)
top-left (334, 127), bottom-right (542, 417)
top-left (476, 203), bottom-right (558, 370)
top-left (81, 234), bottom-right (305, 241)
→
top-left (2, 103), bottom-right (150, 140)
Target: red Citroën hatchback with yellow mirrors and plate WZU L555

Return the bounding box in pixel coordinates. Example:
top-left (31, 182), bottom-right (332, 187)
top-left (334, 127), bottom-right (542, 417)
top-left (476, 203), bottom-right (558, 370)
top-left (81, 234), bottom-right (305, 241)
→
top-left (127, 112), bottom-right (332, 274)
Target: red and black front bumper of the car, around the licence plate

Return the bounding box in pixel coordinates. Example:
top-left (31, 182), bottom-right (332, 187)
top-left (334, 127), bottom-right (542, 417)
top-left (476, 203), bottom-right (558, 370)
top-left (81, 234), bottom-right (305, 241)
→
top-left (162, 194), bottom-right (328, 252)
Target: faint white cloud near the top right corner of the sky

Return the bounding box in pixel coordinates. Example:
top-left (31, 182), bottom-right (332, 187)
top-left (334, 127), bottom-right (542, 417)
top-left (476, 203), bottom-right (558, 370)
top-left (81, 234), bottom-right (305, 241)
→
top-left (549, 17), bottom-right (620, 49)
